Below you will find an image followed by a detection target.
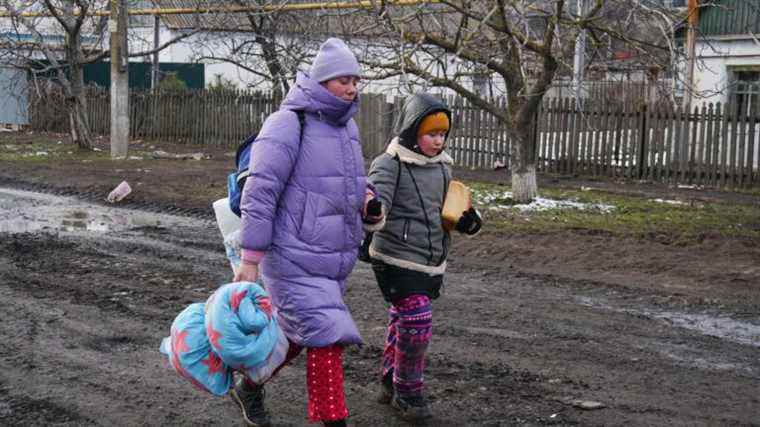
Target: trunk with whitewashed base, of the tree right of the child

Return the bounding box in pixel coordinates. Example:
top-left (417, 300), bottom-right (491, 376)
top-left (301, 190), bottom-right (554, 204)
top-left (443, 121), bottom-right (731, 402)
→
top-left (511, 120), bottom-right (538, 203)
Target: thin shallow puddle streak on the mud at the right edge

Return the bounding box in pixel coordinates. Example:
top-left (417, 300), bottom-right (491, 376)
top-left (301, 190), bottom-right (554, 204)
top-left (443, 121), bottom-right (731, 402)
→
top-left (578, 297), bottom-right (760, 348)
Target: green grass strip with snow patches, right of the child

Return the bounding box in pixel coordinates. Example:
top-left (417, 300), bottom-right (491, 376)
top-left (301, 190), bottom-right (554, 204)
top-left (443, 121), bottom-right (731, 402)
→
top-left (468, 182), bottom-right (760, 244)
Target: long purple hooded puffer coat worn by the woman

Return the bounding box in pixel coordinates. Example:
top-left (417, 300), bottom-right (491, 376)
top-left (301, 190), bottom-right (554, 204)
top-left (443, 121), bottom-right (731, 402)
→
top-left (241, 74), bottom-right (367, 347)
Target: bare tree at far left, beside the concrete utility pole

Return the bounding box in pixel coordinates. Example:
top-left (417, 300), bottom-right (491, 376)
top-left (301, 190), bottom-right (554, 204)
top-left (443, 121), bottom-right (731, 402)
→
top-left (0, 0), bottom-right (199, 149)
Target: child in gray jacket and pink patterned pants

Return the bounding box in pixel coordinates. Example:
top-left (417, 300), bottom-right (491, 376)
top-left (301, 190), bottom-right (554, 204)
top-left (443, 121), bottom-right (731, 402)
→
top-left (368, 94), bottom-right (482, 421)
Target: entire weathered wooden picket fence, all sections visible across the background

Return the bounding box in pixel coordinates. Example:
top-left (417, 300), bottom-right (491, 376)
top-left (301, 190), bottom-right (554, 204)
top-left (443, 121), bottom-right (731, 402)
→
top-left (30, 90), bottom-right (760, 188)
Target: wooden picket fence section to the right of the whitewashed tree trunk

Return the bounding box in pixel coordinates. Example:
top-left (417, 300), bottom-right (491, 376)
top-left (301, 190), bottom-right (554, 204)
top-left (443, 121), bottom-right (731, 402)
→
top-left (535, 99), bottom-right (760, 188)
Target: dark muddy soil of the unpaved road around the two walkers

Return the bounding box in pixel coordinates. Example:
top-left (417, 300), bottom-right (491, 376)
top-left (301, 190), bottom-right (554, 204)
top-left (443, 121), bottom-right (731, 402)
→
top-left (0, 132), bottom-right (760, 426)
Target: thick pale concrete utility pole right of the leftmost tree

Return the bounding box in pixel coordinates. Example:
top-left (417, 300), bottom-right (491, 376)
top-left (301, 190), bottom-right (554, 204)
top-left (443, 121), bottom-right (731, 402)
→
top-left (108, 0), bottom-right (129, 159)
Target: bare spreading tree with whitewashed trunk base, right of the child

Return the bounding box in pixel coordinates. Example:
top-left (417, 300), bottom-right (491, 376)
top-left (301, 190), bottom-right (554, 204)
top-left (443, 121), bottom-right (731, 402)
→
top-left (366, 0), bottom-right (674, 202)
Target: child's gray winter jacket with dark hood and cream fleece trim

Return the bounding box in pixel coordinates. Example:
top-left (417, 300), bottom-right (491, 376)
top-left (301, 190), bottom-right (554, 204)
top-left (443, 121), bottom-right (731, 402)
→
top-left (367, 94), bottom-right (452, 275)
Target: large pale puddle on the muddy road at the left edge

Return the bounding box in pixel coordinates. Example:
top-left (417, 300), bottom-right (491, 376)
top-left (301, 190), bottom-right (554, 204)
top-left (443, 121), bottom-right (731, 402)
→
top-left (0, 188), bottom-right (199, 234)
